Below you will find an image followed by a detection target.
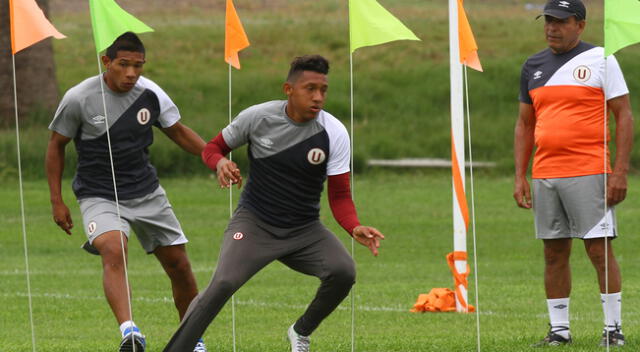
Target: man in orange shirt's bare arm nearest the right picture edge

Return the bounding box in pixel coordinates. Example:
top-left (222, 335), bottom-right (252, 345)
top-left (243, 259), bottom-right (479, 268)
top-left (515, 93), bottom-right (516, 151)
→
top-left (607, 94), bottom-right (633, 206)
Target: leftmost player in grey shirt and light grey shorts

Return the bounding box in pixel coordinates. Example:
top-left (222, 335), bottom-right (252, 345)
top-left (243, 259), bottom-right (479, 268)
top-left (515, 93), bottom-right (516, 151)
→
top-left (46, 33), bottom-right (206, 352)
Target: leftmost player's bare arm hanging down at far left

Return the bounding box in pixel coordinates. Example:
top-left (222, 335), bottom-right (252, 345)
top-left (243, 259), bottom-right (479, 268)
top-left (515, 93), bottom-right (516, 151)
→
top-left (45, 131), bottom-right (73, 235)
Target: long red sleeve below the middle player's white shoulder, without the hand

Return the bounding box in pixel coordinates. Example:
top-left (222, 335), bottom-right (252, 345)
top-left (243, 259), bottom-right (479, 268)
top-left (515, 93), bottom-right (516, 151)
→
top-left (327, 172), bottom-right (360, 235)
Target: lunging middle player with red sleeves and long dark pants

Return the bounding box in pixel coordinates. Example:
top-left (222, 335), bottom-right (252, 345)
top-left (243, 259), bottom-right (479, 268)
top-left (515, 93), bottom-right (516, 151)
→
top-left (164, 55), bottom-right (384, 352)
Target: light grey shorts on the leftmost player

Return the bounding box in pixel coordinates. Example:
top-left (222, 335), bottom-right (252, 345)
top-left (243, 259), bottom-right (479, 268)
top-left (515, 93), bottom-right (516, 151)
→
top-left (78, 186), bottom-right (188, 254)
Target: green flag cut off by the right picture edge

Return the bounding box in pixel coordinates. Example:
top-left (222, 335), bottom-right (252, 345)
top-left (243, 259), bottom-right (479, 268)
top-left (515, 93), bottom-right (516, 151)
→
top-left (604, 0), bottom-right (640, 56)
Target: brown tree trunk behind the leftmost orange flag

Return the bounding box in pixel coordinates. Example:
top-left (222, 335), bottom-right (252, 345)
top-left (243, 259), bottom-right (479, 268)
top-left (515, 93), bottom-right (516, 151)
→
top-left (0, 0), bottom-right (58, 127)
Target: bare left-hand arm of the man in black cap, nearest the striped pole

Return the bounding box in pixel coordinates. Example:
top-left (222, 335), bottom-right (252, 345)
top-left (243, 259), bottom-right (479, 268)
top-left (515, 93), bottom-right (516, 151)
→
top-left (513, 102), bottom-right (536, 209)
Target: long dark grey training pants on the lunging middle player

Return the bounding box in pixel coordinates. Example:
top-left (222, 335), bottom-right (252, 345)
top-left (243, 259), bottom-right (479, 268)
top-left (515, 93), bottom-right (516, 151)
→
top-left (164, 207), bottom-right (355, 352)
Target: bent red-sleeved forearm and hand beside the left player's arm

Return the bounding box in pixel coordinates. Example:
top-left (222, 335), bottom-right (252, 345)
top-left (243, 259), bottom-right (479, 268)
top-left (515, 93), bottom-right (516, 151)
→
top-left (201, 132), bottom-right (242, 189)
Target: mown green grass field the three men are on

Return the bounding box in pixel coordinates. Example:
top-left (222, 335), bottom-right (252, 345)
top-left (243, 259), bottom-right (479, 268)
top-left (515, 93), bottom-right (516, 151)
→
top-left (0, 171), bottom-right (640, 352)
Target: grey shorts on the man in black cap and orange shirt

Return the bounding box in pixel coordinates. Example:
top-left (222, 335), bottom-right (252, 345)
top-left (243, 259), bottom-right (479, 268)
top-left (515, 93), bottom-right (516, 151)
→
top-left (533, 174), bottom-right (616, 239)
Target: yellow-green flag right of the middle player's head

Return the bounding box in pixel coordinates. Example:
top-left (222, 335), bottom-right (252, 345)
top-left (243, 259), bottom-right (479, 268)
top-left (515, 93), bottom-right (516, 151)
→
top-left (349, 0), bottom-right (420, 53)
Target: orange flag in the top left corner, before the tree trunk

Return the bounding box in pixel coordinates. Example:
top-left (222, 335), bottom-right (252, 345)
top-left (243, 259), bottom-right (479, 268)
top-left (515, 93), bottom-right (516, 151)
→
top-left (9, 0), bottom-right (66, 54)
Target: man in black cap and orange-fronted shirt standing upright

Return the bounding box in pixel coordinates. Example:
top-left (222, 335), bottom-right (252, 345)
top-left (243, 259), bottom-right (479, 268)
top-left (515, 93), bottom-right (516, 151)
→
top-left (513, 0), bottom-right (633, 346)
